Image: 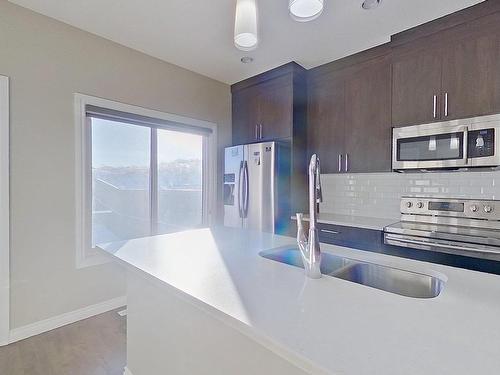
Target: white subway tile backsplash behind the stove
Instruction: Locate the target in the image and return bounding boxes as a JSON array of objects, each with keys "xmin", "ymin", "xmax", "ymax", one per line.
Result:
[{"xmin": 320, "ymin": 171, "xmax": 500, "ymax": 219}]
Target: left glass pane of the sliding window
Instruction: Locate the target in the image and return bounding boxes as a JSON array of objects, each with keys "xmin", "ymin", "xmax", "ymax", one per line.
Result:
[{"xmin": 90, "ymin": 117, "xmax": 152, "ymax": 247}]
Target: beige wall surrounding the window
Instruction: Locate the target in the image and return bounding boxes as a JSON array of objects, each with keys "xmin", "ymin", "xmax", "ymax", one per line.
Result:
[{"xmin": 0, "ymin": 0, "xmax": 231, "ymax": 328}]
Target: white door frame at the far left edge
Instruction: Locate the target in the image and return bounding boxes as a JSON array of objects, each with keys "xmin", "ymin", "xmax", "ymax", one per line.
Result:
[{"xmin": 0, "ymin": 76, "xmax": 10, "ymax": 346}]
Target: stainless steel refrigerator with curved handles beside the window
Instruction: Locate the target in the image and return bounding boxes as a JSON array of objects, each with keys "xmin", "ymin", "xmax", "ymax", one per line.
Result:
[{"xmin": 224, "ymin": 142, "xmax": 291, "ymax": 234}]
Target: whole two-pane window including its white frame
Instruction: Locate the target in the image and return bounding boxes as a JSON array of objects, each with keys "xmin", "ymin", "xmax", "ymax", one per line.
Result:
[{"xmin": 76, "ymin": 94, "xmax": 216, "ymax": 267}]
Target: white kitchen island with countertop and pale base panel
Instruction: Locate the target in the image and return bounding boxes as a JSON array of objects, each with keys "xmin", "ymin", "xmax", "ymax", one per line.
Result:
[{"xmin": 100, "ymin": 227, "xmax": 500, "ymax": 375}]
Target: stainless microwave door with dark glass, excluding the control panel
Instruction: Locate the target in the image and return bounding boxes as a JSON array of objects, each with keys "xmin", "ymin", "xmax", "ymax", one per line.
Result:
[{"xmin": 392, "ymin": 124, "xmax": 468, "ymax": 170}]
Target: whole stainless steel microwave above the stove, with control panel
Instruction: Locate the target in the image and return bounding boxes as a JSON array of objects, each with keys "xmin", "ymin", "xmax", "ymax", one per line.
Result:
[{"xmin": 392, "ymin": 114, "xmax": 500, "ymax": 171}]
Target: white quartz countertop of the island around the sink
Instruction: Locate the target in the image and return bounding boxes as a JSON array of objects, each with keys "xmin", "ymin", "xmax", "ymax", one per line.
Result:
[{"xmin": 100, "ymin": 227, "xmax": 500, "ymax": 375}]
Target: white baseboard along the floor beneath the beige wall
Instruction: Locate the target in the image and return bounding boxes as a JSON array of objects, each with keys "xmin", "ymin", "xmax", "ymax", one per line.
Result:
[{"xmin": 9, "ymin": 296, "xmax": 127, "ymax": 343}]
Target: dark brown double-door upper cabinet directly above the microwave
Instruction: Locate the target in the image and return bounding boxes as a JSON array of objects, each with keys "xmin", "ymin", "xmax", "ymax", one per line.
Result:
[{"xmin": 392, "ymin": 3, "xmax": 500, "ymax": 126}]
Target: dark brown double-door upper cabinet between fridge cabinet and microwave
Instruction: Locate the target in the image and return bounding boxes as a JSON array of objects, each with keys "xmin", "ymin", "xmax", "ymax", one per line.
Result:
[{"xmin": 308, "ymin": 46, "xmax": 391, "ymax": 173}]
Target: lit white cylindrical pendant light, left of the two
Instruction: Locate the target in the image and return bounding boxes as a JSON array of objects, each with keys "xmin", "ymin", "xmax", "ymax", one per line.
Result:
[{"xmin": 234, "ymin": 0, "xmax": 259, "ymax": 51}]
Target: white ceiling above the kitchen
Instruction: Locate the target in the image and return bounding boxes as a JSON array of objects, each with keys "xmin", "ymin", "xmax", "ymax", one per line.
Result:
[{"xmin": 11, "ymin": 0, "xmax": 482, "ymax": 84}]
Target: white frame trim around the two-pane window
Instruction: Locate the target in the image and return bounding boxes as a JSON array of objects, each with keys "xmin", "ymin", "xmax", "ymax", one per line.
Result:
[{"xmin": 74, "ymin": 93, "xmax": 217, "ymax": 268}]
